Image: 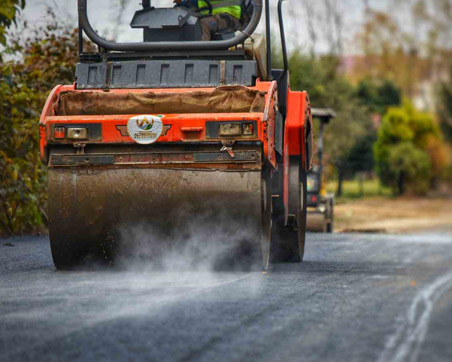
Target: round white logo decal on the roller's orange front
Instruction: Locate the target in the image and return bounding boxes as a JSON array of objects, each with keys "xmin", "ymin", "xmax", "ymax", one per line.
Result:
[{"xmin": 127, "ymin": 115, "xmax": 163, "ymax": 145}]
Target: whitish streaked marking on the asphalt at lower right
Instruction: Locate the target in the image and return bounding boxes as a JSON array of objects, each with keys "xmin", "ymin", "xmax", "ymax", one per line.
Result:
[{"xmin": 378, "ymin": 270, "xmax": 452, "ymax": 362}]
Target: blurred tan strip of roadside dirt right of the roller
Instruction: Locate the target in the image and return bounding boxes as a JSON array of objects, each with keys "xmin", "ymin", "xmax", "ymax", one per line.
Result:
[{"xmin": 335, "ymin": 198, "xmax": 452, "ymax": 233}]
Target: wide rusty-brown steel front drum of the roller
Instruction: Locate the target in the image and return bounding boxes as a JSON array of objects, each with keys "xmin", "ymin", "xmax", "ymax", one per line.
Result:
[{"xmin": 48, "ymin": 168, "xmax": 265, "ymax": 269}]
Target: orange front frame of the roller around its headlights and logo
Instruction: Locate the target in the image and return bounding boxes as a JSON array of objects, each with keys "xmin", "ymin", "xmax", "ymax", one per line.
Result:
[{"xmin": 39, "ymin": 81, "xmax": 277, "ymax": 167}]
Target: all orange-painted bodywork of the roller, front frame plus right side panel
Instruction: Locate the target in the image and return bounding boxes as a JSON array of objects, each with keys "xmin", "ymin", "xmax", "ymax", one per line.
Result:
[{"xmin": 39, "ymin": 80, "xmax": 312, "ymax": 215}]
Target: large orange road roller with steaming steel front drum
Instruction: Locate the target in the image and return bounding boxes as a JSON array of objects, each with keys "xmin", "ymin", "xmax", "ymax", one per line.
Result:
[{"xmin": 40, "ymin": 0, "xmax": 313, "ymax": 269}]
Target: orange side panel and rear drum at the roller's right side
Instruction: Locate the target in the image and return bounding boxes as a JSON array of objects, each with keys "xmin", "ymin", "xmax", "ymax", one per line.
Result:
[{"xmin": 272, "ymin": 90, "xmax": 313, "ymax": 263}]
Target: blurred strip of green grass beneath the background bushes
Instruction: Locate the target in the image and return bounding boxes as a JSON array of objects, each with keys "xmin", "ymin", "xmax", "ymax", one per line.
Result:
[{"xmin": 326, "ymin": 178, "xmax": 392, "ymax": 200}]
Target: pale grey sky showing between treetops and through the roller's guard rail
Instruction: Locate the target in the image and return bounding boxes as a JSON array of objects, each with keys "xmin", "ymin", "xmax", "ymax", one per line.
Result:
[{"xmin": 21, "ymin": 0, "xmax": 391, "ymax": 54}]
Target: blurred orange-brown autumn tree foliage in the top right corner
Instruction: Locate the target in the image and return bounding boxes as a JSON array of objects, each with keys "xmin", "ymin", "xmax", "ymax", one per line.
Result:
[{"xmin": 352, "ymin": 0, "xmax": 452, "ymax": 110}]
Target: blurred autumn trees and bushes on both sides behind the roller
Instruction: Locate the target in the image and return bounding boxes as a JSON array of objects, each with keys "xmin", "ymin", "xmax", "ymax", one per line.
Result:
[{"xmin": 0, "ymin": 0, "xmax": 452, "ymax": 235}]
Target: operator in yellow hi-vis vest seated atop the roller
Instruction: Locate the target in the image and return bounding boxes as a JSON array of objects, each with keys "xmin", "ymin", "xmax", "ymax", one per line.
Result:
[{"xmin": 174, "ymin": 0, "xmax": 243, "ymax": 41}]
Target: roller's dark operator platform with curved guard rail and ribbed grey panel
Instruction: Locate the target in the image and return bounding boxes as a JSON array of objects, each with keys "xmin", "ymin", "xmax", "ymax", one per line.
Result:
[{"xmin": 76, "ymin": 0, "xmax": 272, "ymax": 89}]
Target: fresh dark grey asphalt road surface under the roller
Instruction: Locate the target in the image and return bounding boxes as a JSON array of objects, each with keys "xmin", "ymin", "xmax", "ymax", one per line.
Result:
[{"xmin": 0, "ymin": 233, "xmax": 452, "ymax": 362}]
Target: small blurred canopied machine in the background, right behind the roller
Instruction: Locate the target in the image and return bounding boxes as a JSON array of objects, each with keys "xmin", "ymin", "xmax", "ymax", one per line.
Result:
[{"xmin": 307, "ymin": 108, "xmax": 336, "ymax": 233}]
